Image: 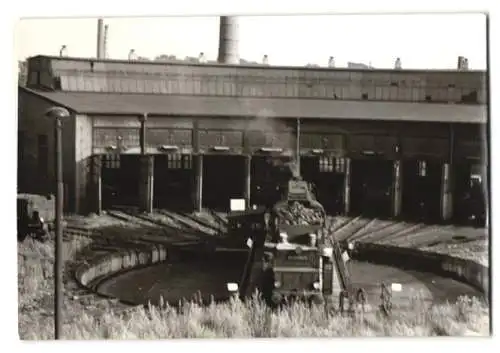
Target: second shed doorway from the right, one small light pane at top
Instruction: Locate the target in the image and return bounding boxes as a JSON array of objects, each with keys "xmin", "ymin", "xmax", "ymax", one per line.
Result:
[{"xmin": 402, "ymin": 159, "xmax": 443, "ymax": 223}]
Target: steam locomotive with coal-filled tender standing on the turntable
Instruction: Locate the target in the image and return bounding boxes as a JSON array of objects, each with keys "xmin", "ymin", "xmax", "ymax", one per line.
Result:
[{"xmin": 228, "ymin": 177, "xmax": 347, "ymax": 303}]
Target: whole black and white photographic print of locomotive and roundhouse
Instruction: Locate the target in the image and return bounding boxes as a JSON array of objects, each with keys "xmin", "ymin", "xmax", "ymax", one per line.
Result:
[{"xmin": 10, "ymin": 1, "xmax": 492, "ymax": 341}]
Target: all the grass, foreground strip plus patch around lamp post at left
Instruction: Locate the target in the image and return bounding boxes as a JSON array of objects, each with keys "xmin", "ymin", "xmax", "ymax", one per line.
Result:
[{"xmin": 18, "ymin": 239, "xmax": 489, "ymax": 340}]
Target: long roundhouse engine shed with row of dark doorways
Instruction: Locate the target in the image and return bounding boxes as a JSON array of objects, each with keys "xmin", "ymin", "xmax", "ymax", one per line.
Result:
[{"xmin": 18, "ymin": 56, "xmax": 488, "ymax": 221}]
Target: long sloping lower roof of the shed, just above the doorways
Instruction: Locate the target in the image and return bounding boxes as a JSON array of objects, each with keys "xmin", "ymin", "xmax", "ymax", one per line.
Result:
[{"xmin": 20, "ymin": 87, "xmax": 487, "ymax": 123}]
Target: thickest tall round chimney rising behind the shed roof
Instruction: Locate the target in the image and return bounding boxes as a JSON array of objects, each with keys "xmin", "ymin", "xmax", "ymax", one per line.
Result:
[{"xmin": 217, "ymin": 16, "xmax": 240, "ymax": 64}]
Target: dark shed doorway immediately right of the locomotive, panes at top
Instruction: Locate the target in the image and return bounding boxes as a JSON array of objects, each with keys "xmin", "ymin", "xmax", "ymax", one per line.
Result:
[{"xmin": 300, "ymin": 157, "xmax": 346, "ymax": 215}]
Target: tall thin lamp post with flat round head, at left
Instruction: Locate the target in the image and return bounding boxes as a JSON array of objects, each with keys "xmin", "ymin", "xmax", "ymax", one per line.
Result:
[{"xmin": 45, "ymin": 107, "xmax": 70, "ymax": 340}]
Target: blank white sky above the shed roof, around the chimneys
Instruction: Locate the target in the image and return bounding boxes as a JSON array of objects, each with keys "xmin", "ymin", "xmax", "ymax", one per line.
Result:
[{"xmin": 15, "ymin": 14, "xmax": 486, "ymax": 70}]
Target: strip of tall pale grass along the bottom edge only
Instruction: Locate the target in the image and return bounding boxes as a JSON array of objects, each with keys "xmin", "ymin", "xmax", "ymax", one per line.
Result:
[{"xmin": 24, "ymin": 292, "xmax": 488, "ymax": 339}]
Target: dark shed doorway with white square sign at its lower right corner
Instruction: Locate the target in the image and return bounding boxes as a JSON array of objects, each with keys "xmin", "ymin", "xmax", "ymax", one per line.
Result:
[{"xmin": 202, "ymin": 155, "xmax": 245, "ymax": 212}]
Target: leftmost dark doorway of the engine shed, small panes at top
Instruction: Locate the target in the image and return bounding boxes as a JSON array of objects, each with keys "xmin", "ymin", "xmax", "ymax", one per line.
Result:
[{"xmin": 101, "ymin": 154, "xmax": 141, "ymax": 209}]
